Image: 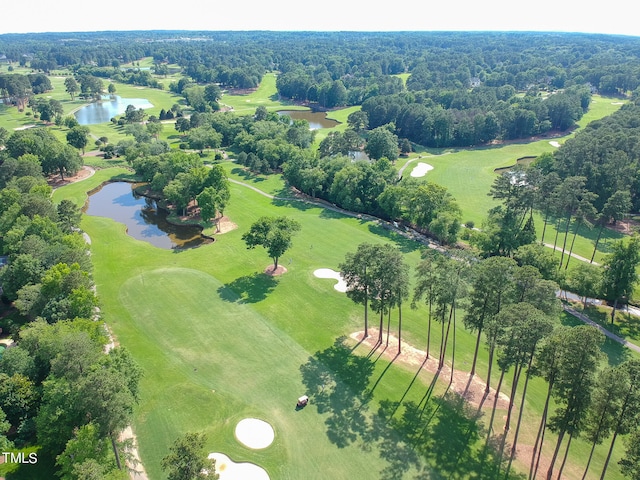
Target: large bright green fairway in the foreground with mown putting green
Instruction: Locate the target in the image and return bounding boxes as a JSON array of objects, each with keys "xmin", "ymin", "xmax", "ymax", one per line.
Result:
[{"xmin": 47, "ymin": 163, "xmax": 629, "ymax": 480}]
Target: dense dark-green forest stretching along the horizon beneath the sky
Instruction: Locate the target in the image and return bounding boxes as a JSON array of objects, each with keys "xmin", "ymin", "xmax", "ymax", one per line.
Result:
[{"xmin": 0, "ymin": 32, "xmax": 640, "ymax": 147}]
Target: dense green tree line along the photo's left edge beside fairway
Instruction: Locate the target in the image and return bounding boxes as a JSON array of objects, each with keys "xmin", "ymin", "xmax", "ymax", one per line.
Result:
[{"xmin": 0, "ymin": 135, "xmax": 141, "ymax": 479}]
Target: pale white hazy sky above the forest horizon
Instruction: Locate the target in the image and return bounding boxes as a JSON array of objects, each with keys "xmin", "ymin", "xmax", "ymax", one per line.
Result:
[{"xmin": 0, "ymin": 0, "xmax": 640, "ymax": 36}]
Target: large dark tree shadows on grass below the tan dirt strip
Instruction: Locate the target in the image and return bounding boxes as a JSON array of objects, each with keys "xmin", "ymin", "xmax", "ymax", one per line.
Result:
[{"xmin": 300, "ymin": 338, "xmax": 524, "ymax": 480}]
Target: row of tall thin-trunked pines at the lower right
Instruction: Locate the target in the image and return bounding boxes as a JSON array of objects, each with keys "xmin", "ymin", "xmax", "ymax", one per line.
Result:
[{"xmin": 339, "ymin": 243, "xmax": 640, "ymax": 478}]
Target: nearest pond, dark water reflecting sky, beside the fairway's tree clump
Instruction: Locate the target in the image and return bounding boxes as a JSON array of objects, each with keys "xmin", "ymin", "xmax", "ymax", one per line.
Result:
[{"xmin": 85, "ymin": 182, "xmax": 212, "ymax": 250}]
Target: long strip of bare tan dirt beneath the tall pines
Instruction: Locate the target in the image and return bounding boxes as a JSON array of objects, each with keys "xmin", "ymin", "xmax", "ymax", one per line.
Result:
[{"xmin": 350, "ymin": 328, "xmax": 510, "ymax": 411}]
